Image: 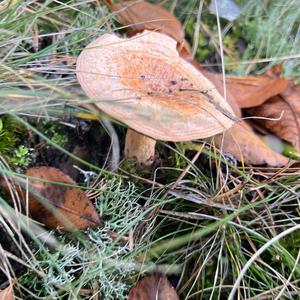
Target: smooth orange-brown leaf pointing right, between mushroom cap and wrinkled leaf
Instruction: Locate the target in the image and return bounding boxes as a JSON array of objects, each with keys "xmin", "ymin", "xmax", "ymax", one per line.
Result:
[{"xmin": 226, "ymin": 73, "xmax": 289, "ymax": 108}]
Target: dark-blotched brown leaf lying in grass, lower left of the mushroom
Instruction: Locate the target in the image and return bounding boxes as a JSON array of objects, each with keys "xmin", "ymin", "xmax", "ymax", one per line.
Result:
[{"xmin": 2, "ymin": 167, "xmax": 100, "ymax": 231}]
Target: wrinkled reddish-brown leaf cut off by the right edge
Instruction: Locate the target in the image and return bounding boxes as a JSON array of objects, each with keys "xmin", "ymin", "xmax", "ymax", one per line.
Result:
[{"xmin": 248, "ymin": 82, "xmax": 300, "ymax": 151}]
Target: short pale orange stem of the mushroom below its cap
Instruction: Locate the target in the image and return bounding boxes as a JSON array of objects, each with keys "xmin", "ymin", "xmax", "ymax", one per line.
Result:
[{"xmin": 124, "ymin": 129, "xmax": 156, "ymax": 166}]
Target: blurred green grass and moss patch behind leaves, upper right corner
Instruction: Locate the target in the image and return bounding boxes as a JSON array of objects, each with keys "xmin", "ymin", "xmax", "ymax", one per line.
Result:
[{"xmin": 177, "ymin": 0, "xmax": 300, "ymax": 81}]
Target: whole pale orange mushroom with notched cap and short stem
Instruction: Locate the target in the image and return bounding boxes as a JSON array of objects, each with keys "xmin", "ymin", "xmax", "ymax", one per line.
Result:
[{"xmin": 76, "ymin": 31, "xmax": 235, "ymax": 165}]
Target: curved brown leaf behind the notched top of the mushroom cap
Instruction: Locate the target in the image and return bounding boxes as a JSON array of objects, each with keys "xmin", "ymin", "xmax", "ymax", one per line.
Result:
[{"xmin": 104, "ymin": 0, "xmax": 193, "ymax": 61}]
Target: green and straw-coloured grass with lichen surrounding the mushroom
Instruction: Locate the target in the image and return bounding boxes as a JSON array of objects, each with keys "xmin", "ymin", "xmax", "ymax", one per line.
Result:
[{"xmin": 0, "ymin": 0, "xmax": 300, "ymax": 299}]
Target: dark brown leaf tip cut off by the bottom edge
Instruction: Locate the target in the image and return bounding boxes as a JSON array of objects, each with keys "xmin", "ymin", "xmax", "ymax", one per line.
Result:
[{"xmin": 127, "ymin": 275, "xmax": 179, "ymax": 300}]
